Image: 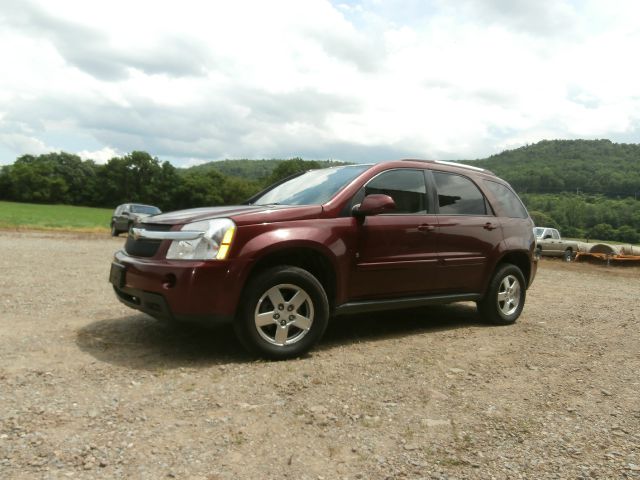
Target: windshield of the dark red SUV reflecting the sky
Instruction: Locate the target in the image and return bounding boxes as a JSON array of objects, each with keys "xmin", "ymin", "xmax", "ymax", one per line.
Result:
[{"xmin": 251, "ymin": 165, "xmax": 371, "ymax": 205}]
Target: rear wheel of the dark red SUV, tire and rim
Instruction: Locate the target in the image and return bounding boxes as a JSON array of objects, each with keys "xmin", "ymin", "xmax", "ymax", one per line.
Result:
[{"xmin": 477, "ymin": 263, "xmax": 527, "ymax": 325}]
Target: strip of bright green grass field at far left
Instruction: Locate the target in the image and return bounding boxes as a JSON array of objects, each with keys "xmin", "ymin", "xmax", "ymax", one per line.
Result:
[{"xmin": 0, "ymin": 202, "xmax": 113, "ymax": 232}]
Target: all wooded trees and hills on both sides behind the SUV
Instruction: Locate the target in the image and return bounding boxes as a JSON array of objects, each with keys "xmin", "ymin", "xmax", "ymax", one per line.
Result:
[{"xmin": 0, "ymin": 140, "xmax": 640, "ymax": 243}]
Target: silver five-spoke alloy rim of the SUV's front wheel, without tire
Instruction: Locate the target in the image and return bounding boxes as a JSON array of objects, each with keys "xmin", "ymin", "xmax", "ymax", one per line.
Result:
[{"xmin": 253, "ymin": 283, "xmax": 314, "ymax": 347}]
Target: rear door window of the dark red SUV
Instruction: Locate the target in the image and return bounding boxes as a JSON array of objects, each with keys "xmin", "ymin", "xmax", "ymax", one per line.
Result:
[{"xmin": 433, "ymin": 172, "xmax": 487, "ymax": 215}]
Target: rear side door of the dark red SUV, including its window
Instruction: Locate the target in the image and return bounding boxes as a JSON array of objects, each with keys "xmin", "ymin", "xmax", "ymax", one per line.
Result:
[{"xmin": 432, "ymin": 171, "xmax": 503, "ymax": 293}]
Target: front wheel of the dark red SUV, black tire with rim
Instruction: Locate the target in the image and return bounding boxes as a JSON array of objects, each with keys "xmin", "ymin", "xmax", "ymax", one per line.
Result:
[{"xmin": 234, "ymin": 265, "xmax": 329, "ymax": 360}]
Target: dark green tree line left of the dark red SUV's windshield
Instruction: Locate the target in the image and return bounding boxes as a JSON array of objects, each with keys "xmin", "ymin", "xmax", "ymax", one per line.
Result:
[{"xmin": 0, "ymin": 151, "xmax": 322, "ymax": 210}]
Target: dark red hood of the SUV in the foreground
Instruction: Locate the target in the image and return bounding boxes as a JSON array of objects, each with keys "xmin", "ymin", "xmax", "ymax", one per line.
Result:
[{"xmin": 143, "ymin": 205, "xmax": 322, "ymax": 225}]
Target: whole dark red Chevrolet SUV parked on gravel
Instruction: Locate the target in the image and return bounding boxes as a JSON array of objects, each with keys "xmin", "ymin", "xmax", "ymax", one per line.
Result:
[{"xmin": 110, "ymin": 160, "xmax": 537, "ymax": 358}]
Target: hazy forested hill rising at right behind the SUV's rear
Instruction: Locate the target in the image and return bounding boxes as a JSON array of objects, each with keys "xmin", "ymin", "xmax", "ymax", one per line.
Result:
[{"xmin": 464, "ymin": 140, "xmax": 640, "ymax": 198}]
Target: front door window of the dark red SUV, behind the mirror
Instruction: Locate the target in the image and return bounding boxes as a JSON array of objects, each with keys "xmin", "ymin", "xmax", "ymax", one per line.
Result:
[{"xmin": 362, "ymin": 168, "xmax": 429, "ymax": 213}]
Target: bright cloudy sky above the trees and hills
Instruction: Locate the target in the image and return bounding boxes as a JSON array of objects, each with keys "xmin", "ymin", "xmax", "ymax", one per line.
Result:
[{"xmin": 0, "ymin": 0, "xmax": 640, "ymax": 167}]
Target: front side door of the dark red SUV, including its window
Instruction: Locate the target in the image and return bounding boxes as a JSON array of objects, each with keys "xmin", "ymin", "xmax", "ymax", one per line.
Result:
[{"xmin": 349, "ymin": 168, "xmax": 438, "ymax": 299}]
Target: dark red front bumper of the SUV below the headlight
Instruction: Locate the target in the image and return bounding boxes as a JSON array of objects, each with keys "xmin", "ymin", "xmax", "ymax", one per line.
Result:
[{"xmin": 109, "ymin": 250, "xmax": 247, "ymax": 323}]
